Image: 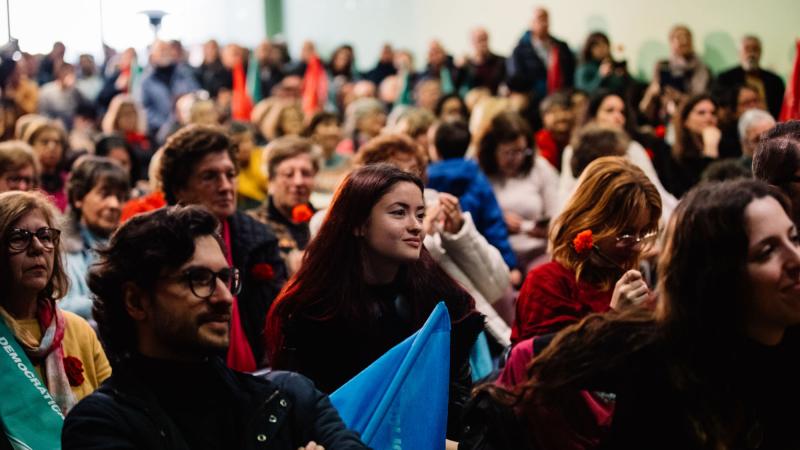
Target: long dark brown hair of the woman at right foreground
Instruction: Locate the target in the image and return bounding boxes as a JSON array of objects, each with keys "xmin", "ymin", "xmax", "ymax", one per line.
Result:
[{"xmin": 481, "ymin": 180, "xmax": 790, "ymax": 448}]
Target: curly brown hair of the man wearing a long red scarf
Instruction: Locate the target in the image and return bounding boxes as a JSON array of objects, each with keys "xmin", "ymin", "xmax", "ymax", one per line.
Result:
[{"xmin": 161, "ymin": 125, "xmax": 236, "ymax": 205}]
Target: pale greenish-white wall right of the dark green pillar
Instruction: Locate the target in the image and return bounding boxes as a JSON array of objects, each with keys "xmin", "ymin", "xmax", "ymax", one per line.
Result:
[{"xmin": 284, "ymin": 0, "xmax": 800, "ymax": 81}]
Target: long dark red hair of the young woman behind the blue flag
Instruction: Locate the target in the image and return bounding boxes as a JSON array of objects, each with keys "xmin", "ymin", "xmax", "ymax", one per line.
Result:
[{"xmin": 265, "ymin": 164, "xmax": 473, "ymax": 367}]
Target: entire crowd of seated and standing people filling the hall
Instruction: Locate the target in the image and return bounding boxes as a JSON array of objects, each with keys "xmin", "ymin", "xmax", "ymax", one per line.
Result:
[{"xmin": 0, "ymin": 7, "xmax": 800, "ymax": 450}]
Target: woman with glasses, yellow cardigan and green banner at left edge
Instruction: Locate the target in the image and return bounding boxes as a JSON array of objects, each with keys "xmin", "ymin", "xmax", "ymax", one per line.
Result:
[{"xmin": 0, "ymin": 191, "xmax": 111, "ymax": 448}]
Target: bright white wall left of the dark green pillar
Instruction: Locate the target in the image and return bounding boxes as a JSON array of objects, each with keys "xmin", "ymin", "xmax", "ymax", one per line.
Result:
[{"xmin": 5, "ymin": 0, "xmax": 266, "ymax": 60}]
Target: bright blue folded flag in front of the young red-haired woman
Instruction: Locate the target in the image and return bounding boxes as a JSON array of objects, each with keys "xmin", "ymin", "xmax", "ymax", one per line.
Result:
[{"xmin": 330, "ymin": 302, "xmax": 450, "ymax": 450}]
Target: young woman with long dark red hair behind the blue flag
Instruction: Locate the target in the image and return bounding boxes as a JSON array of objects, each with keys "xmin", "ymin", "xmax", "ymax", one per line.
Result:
[{"xmin": 265, "ymin": 164, "xmax": 483, "ymax": 440}]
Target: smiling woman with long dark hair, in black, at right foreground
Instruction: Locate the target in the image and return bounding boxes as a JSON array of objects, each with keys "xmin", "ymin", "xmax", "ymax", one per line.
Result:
[{"xmin": 459, "ymin": 180, "xmax": 800, "ymax": 450}]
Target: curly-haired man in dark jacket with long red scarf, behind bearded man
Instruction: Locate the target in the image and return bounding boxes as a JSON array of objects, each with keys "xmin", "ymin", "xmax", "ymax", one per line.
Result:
[{"xmin": 161, "ymin": 125, "xmax": 286, "ymax": 372}]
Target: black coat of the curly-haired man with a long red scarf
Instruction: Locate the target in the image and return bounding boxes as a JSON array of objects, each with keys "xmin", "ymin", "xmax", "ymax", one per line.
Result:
[{"xmin": 228, "ymin": 211, "xmax": 286, "ymax": 367}]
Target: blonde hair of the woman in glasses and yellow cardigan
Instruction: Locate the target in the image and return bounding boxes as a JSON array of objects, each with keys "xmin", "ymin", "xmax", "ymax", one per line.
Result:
[{"xmin": 0, "ymin": 191, "xmax": 69, "ymax": 300}]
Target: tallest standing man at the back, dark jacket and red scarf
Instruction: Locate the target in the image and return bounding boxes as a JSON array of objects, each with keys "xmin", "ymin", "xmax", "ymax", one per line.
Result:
[{"xmin": 506, "ymin": 7, "xmax": 575, "ymax": 98}]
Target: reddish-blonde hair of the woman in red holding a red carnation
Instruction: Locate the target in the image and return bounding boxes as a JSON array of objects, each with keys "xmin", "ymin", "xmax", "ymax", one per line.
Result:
[{"xmin": 550, "ymin": 156, "xmax": 661, "ymax": 289}]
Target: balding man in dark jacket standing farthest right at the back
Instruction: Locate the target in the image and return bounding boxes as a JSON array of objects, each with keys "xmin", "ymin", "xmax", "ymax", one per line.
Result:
[{"xmin": 717, "ymin": 36, "xmax": 785, "ymax": 118}]
